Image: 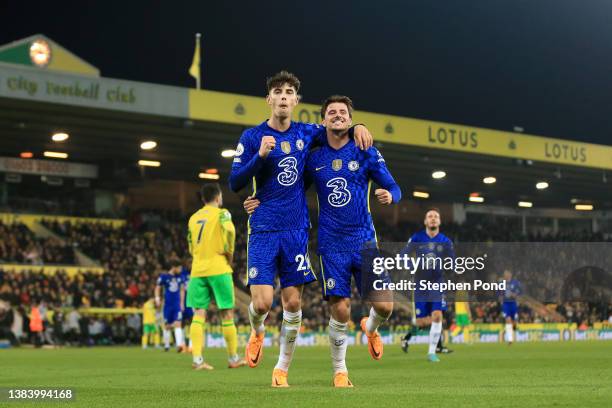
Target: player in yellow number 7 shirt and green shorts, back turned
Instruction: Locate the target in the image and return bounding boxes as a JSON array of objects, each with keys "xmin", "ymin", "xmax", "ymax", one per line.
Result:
[{"xmin": 187, "ymin": 183, "xmax": 246, "ymax": 370}]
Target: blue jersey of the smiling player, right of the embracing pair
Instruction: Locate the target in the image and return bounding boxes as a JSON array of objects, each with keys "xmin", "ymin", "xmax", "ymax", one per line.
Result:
[{"xmin": 306, "ymin": 139, "xmax": 401, "ymax": 254}]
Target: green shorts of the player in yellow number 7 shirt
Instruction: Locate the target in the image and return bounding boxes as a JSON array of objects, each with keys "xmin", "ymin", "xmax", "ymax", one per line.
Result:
[{"xmin": 187, "ymin": 273, "xmax": 235, "ymax": 310}]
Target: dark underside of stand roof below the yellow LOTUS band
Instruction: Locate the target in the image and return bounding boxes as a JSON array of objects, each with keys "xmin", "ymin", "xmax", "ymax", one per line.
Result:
[{"xmin": 0, "ymin": 98, "xmax": 612, "ymax": 209}]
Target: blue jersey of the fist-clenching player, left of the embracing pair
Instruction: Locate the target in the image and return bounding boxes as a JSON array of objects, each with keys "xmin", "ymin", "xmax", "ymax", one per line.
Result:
[{"xmin": 230, "ymin": 121, "xmax": 325, "ymax": 232}]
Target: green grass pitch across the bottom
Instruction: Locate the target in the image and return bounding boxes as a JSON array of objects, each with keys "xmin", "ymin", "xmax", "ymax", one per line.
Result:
[{"xmin": 0, "ymin": 341, "xmax": 612, "ymax": 408}]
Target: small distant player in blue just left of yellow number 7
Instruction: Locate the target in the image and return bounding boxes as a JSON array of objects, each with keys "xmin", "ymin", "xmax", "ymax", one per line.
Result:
[{"xmin": 155, "ymin": 259, "xmax": 185, "ymax": 353}]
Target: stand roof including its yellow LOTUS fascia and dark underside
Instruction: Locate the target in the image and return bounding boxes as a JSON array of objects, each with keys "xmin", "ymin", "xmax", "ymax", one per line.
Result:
[{"xmin": 0, "ymin": 35, "xmax": 612, "ymax": 209}]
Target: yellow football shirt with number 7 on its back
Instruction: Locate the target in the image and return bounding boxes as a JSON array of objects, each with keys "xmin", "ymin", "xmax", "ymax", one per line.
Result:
[{"xmin": 187, "ymin": 205, "xmax": 236, "ymax": 278}]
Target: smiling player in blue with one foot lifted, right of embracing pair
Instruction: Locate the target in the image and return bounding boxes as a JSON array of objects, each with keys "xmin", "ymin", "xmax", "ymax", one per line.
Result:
[{"xmin": 245, "ymin": 95, "xmax": 401, "ymax": 387}]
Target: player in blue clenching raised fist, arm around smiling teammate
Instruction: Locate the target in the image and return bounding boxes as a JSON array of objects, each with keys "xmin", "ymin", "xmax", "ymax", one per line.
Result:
[{"xmin": 230, "ymin": 71, "xmax": 372, "ymax": 387}]
